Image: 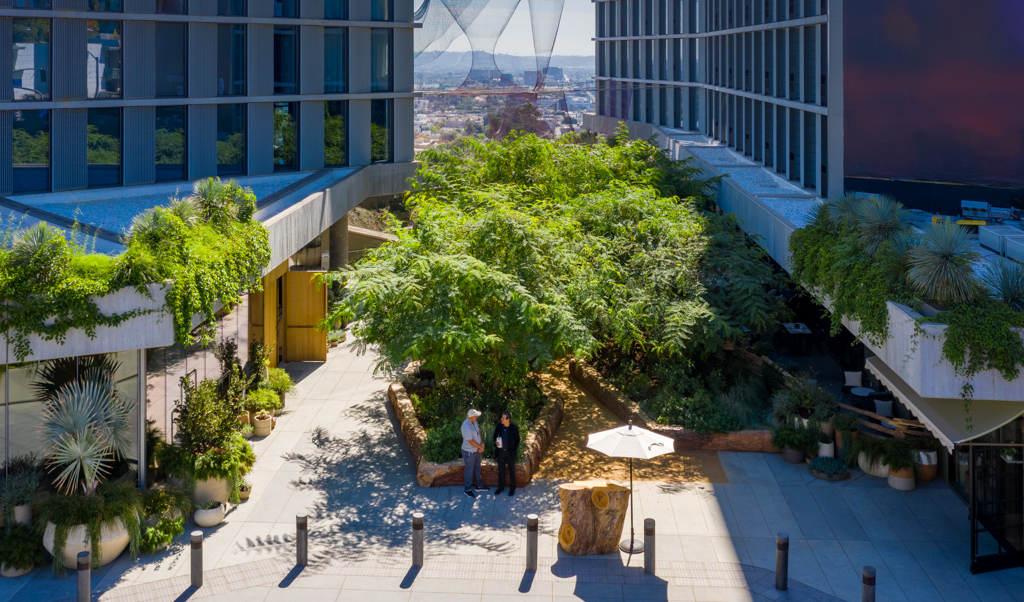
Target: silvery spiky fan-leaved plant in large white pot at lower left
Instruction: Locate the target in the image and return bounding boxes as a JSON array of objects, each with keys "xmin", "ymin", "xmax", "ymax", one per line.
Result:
[{"xmin": 42, "ymin": 371, "xmax": 131, "ymax": 495}]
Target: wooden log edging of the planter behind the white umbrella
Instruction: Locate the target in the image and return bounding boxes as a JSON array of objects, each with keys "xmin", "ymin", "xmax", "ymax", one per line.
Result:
[{"xmin": 569, "ymin": 359, "xmax": 778, "ymax": 453}]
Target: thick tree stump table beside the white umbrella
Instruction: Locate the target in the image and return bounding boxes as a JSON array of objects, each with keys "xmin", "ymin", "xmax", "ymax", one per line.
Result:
[{"xmin": 558, "ymin": 481, "xmax": 630, "ymax": 556}]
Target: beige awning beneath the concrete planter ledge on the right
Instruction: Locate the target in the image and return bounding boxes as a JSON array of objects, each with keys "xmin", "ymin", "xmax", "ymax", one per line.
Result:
[{"xmin": 867, "ymin": 357, "xmax": 1024, "ymax": 453}]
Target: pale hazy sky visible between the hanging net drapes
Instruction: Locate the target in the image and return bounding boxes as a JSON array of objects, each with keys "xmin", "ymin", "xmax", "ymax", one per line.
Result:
[{"xmin": 449, "ymin": 0, "xmax": 594, "ymax": 56}]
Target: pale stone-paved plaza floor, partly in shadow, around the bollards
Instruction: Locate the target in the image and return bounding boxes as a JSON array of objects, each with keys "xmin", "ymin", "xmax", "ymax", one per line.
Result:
[{"xmin": 0, "ymin": 345, "xmax": 1024, "ymax": 602}]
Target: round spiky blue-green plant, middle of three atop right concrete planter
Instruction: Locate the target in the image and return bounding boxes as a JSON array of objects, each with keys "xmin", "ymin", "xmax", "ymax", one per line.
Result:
[{"xmin": 907, "ymin": 219, "xmax": 978, "ymax": 304}]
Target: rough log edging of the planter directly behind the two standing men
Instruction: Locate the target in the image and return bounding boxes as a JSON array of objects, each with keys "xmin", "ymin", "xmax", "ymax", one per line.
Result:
[{"xmin": 387, "ymin": 366, "xmax": 565, "ymax": 487}]
